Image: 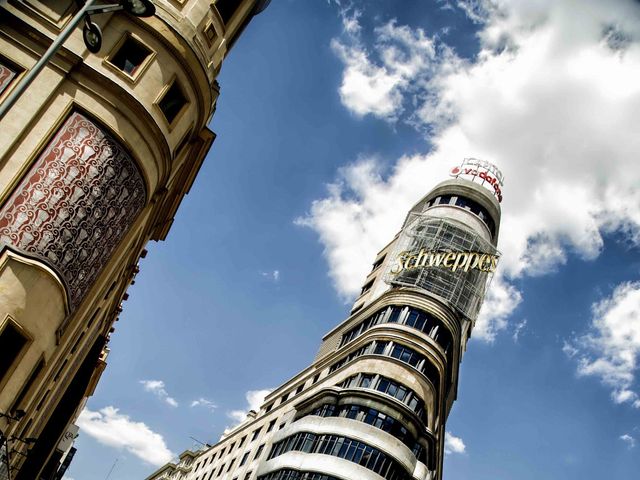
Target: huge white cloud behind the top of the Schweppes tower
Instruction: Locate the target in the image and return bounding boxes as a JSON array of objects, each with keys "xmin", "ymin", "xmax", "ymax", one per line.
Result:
[{"xmin": 296, "ymin": 0, "xmax": 640, "ymax": 340}]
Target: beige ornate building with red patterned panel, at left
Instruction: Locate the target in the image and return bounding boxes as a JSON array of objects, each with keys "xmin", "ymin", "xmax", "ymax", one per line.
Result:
[{"xmin": 0, "ymin": 0, "xmax": 269, "ymax": 480}]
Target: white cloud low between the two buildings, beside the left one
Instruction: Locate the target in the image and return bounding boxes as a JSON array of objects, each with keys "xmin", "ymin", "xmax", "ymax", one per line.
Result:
[{"xmin": 78, "ymin": 406, "xmax": 174, "ymax": 466}]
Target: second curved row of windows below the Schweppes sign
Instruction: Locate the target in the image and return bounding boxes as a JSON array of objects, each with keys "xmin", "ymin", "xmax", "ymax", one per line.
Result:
[{"xmin": 329, "ymin": 340, "xmax": 440, "ymax": 394}]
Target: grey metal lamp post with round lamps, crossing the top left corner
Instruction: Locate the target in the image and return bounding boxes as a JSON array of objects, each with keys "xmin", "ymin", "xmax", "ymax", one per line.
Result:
[{"xmin": 0, "ymin": 0, "xmax": 156, "ymax": 120}]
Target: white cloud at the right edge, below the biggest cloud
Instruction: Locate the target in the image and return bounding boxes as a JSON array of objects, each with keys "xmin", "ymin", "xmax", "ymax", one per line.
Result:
[{"xmin": 563, "ymin": 282, "xmax": 640, "ymax": 408}]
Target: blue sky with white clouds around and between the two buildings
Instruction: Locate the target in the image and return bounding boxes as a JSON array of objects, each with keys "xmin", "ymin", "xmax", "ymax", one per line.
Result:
[{"xmin": 67, "ymin": 0, "xmax": 640, "ymax": 480}]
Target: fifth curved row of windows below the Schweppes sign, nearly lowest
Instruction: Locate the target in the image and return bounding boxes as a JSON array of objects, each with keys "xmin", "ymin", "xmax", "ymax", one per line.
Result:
[{"xmin": 269, "ymin": 432, "xmax": 411, "ymax": 480}]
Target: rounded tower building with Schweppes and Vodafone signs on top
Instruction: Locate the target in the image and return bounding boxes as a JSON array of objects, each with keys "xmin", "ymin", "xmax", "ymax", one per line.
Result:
[{"xmin": 147, "ymin": 163, "xmax": 502, "ymax": 480}]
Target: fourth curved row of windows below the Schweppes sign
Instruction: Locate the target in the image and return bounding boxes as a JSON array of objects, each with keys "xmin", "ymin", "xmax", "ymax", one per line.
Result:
[{"xmin": 310, "ymin": 403, "xmax": 427, "ymax": 463}]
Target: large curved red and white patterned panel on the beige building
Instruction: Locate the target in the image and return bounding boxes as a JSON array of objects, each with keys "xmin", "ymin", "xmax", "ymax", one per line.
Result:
[{"xmin": 0, "ymin": 112, "xmax": 146, "ymax": 310}]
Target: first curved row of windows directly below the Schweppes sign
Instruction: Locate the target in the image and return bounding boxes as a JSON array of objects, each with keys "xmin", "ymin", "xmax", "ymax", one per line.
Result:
[{"xmin": 340, "ymin": 305, "xmax": 453, "ymax": 354}]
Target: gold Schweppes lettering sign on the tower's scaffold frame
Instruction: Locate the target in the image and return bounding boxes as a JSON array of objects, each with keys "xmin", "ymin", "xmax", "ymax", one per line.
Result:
[{"xmin": 390, "ymin": 248, "xmax": 499, "ymax": 275}]
